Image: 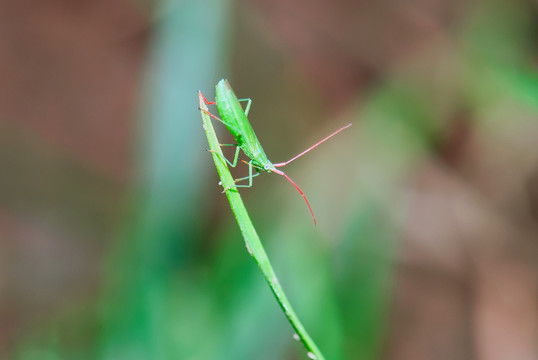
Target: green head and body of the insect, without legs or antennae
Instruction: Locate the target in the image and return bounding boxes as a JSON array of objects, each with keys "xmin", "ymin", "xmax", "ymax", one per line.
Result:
[{"xmin": 215, "ymin": 79, "xmax": 274, "ymax": 172}]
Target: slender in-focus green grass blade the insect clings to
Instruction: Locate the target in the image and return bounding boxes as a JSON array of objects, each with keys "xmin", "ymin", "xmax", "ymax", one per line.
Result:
[{"xmin": 200, "ymin": 93, "xmax": 325, "ymax": 360}]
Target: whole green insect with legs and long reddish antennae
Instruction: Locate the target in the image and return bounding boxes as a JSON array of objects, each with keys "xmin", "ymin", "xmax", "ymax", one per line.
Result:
[{"xmin": 199, "ymin": 79, "xmax": 351, "ymax": 225}]
